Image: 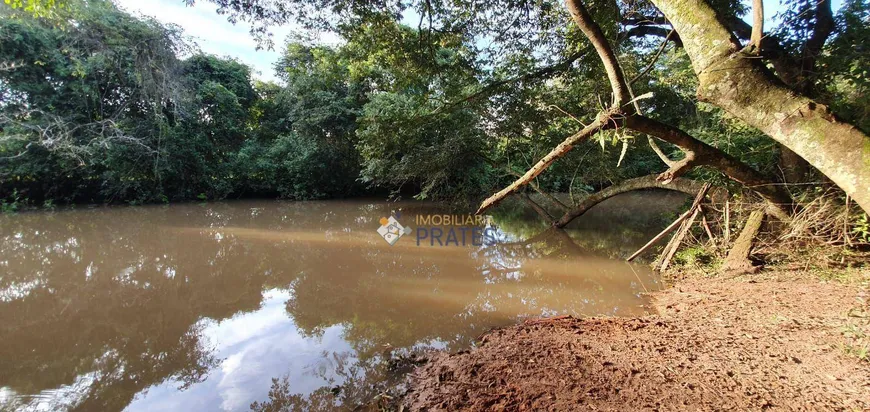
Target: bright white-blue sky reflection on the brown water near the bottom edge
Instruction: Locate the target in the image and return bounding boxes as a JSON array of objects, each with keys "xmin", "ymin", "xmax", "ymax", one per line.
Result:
[{"xmin": 128, "ymin": 290, "xmax": 352, "ymax": 411}]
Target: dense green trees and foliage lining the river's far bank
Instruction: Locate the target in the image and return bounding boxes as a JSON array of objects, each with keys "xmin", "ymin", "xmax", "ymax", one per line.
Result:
[{"xmin": 0, "ymin": 0, "xmax": 870, "ymax": 205}]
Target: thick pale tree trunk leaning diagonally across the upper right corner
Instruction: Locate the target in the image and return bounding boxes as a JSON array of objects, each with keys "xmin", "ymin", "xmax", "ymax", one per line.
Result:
[{"xmin": 652, "ymin": 0, "xmax": 870, "ymax": 211}]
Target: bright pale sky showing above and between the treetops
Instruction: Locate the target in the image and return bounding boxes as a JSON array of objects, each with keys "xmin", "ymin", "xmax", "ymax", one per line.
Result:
[{"xmin": 115, "ymin": 0, "xmax": 843, "ymax": 81}]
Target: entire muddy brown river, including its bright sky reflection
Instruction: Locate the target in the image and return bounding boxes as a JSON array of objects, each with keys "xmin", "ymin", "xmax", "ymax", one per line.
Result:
[{"xmin": 0, "ymin": 193, "xmax": 684, "ymax": 411}]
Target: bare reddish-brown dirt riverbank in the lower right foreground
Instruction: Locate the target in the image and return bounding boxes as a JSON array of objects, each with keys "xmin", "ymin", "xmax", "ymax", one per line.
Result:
[{"xmin": 404, "ymin": 270, "xmax": 870, "ymax": 410}]
